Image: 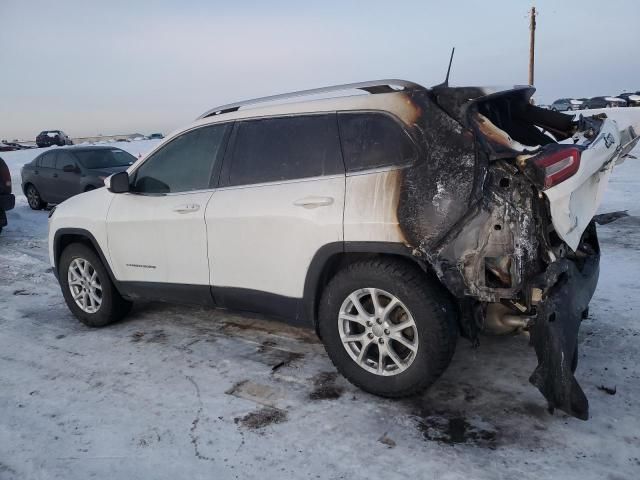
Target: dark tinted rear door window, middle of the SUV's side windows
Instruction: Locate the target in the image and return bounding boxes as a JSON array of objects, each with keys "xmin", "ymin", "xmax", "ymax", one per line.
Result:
[{"xmin": 229, "ymin": 114, "xmax": 344, "ymax": 185}]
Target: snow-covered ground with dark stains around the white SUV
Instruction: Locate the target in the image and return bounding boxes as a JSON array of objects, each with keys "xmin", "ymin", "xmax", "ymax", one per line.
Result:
[{"xmin": 0, "ymin": 127, "xmax": 640, "ymax": 480}]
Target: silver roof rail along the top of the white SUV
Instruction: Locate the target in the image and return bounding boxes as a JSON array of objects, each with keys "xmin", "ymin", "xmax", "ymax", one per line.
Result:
[{"xmin": 197, "ymin": 79, "xmax": 424, "ymax": 120}]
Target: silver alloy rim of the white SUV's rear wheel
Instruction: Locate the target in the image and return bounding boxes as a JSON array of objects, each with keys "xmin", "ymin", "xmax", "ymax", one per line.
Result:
[{"xmin": 338, "ymin": 288, "xmax": 419, "ymax": 376}]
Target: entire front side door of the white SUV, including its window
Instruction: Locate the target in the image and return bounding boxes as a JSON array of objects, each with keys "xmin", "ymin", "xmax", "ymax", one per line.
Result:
[{"xmin": 107, "ymin": 125, "xmax": 231, "ymax": 288}]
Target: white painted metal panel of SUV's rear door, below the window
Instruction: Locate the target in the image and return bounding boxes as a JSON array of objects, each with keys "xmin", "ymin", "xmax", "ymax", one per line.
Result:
[{"xmin": 208, "ymin": 175, "xmax": 345, "ymax": 298}]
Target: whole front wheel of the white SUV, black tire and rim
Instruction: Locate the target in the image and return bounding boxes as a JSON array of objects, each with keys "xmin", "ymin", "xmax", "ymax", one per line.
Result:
[{"xmin": 58, "ymin": 243, "xmax": 132, "ymax": 327}]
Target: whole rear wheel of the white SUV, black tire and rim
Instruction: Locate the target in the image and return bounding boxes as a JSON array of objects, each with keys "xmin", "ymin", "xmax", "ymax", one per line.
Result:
[{"xmin": 319, "ymin": 259, "xmax": 458, "ymax": 398}]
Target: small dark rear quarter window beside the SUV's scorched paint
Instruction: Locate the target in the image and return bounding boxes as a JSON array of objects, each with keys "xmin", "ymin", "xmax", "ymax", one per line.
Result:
[{"xmin": 338, "ymin": 113, "xmax": 416, "ymax": 172}]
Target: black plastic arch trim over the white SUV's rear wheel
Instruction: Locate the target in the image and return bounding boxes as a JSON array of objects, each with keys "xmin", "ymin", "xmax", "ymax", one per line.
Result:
[{"xmin": 298, "ymin": 242, "xmax": 441, "ymax": 335}]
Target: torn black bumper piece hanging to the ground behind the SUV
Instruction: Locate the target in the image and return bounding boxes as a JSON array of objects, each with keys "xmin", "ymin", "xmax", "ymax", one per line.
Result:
[{"xmin": 529, "ymin": 253, "xmax": 600, "ymax": 420}]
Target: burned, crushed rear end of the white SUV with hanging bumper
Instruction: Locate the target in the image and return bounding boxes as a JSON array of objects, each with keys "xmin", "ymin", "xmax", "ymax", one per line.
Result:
[{"xmin": 407, "ymin": 87, "xmax": 632, "ymax": 419}]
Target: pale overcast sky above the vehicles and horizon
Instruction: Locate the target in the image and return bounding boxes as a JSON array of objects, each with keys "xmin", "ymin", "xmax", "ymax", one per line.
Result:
[{"xmin": 0, "ymin": 0, "xmax": 640, "ymax": 139}]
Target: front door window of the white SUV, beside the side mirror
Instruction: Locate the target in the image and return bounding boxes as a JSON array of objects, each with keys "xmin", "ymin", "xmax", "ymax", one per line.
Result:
[{"xmin": 133, "ymin": 125, "xmax": 230, "ymax": 193}]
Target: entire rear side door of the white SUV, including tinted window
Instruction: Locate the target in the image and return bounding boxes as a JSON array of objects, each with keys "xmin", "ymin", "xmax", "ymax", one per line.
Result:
[{"xmin": 206, "ymin": 113, "xmax": 345, "ymax": 306}]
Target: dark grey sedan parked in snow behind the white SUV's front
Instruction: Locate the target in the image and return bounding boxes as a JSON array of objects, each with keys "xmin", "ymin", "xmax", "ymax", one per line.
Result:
[{"xmin": 21, "ymin": 146, "xmax": 136, "ymax": 210}]
